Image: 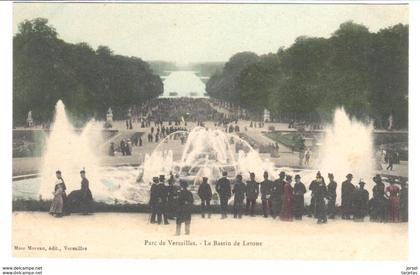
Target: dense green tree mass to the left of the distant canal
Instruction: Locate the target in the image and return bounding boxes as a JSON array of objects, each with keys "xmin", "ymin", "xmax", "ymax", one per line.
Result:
[{"xmin": 13, "ymin": 18, "xmax": 163, "ymax": 125}]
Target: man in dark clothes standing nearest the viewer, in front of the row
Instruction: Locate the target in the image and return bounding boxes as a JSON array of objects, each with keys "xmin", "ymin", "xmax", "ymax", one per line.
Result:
[{"xmin": 176, "ymin": 181, "xmax": 194, "ymax": 235}]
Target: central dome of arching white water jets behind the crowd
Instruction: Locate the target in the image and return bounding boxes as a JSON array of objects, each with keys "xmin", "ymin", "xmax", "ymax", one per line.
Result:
[{"xmin": 140, "ymin": 127, "xmax": 275, "ymax": 187}]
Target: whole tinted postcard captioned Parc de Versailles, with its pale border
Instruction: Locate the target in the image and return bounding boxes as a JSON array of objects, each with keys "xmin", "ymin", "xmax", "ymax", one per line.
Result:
[{"xmin": 4, "ymin": 2, "xmax": 412, "ymax": 271}]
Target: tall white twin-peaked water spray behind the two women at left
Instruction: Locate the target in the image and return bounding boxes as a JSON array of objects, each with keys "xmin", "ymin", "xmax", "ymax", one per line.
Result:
[{"xmin": 39, "ymin": 100, "xmax": 103, "ymax": 199}]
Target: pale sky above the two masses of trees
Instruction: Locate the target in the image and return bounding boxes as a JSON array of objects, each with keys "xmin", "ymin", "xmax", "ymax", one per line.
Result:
[{"xmin": 13, "ymin": 3, "xmax": 409, "ymax": 64}]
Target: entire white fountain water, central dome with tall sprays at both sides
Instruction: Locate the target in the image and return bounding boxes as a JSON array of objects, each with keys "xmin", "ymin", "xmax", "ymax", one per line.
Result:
[{"xmin": 13, "ymin": 101, "xmax": 374, "ymax": 207}]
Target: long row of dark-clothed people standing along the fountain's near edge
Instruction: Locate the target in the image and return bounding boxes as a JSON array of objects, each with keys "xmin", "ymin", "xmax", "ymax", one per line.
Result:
[{"xmin": 149, "ymin": 171, "xmax": 408, "ymax": 235}]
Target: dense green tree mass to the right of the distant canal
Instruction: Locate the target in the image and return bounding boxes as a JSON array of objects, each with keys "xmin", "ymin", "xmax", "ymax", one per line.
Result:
[{"xmin": 206, "ymin": 22, "xmax": 408, "ymax": 128}]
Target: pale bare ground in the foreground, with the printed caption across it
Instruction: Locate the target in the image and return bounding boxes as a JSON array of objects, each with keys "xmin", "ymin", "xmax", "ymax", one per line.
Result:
[{"xmin": 12, "ymin": 212, "xmax": 408, "ymax": 261}]
